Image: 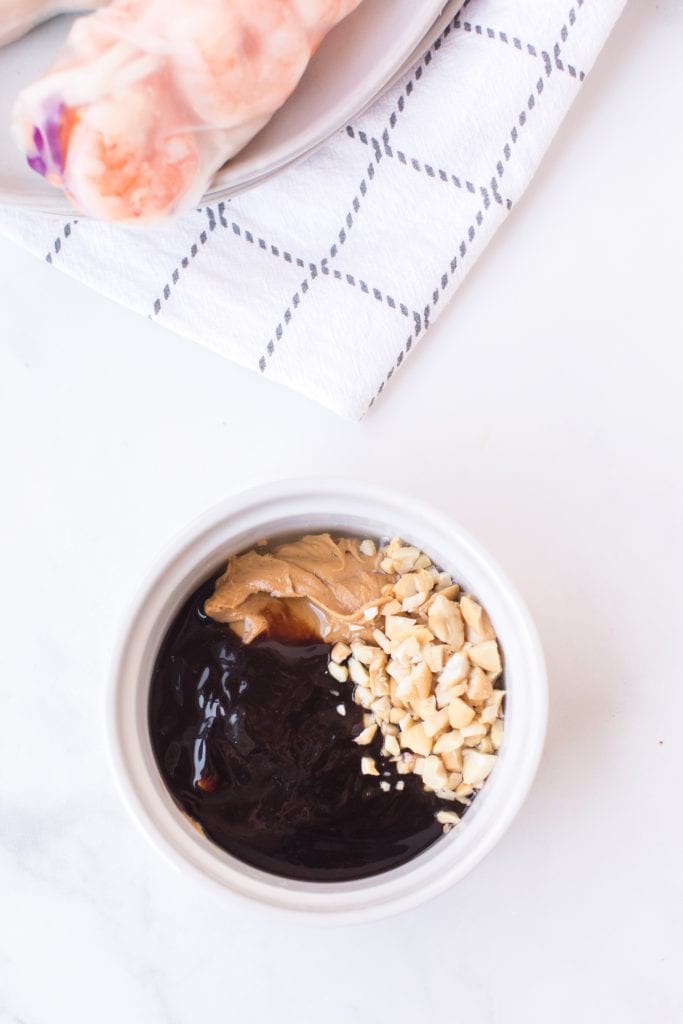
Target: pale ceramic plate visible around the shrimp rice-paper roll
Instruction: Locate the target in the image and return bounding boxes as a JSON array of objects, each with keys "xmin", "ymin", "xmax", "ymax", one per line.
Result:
[{"xmin": 0, "ymin": 0, "xmax": 462, "ymax": 213}]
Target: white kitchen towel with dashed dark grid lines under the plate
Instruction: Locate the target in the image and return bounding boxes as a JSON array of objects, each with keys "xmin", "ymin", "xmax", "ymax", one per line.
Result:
[{"xmin": 0, "ymin": 0, "xmax": 625, "ymax": 419}]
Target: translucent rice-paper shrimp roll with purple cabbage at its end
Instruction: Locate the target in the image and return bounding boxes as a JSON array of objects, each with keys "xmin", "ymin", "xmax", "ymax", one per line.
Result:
[{"xmin": 13, "ymin": 0, "xmax": 360, "ymax": 223}]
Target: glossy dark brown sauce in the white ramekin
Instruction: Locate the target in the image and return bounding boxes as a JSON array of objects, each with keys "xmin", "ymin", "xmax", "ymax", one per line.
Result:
[{"xmin": 148, "ymin": 580, "xmax": 463, "ymax": 882}]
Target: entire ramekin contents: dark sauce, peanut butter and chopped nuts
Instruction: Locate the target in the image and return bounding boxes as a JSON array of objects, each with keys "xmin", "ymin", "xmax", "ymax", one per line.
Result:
[{"xmin": 148, "ymin": 534, "xmax": 505, "ymax": 882}]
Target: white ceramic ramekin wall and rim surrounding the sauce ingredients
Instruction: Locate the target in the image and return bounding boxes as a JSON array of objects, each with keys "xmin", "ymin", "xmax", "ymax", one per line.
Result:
[{"xmin": 108, "ymin": 479, "xmax": 547, "ymax": 923}]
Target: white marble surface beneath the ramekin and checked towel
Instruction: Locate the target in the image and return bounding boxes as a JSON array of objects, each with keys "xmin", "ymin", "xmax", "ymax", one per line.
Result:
[{"xmin": 0, "ymin": 0, "xmax": 683, "ymax": 1024}]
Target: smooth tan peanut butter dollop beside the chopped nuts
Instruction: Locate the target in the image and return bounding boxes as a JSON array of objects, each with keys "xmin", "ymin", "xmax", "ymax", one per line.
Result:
[{"xmin": 204, "ymin": 534, "xmax": 394, "ymax": 643}]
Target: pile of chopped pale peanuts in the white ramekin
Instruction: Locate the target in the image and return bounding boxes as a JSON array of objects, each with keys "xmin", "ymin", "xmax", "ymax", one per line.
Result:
[{"xmin": 329, "ymin": 538, "xmax": 505, "ymax": 831}]
